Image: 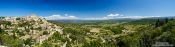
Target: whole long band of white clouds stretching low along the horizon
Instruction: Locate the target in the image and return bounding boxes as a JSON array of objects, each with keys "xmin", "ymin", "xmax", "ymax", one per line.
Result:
[{"xmin": 43, "ymin": 14, "xmax": 163, "ymax": 20}]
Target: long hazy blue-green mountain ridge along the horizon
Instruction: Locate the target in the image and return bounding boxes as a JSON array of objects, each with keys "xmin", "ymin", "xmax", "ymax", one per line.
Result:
[{"xmin": 48, "ymin": 16, "xmax": 175, "ymax": 23}]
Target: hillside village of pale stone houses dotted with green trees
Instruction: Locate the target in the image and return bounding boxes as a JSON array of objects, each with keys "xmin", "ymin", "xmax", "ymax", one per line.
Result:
[{"xmin": 0, "ymin": 15, "xmax": 63, "ymax": 46}]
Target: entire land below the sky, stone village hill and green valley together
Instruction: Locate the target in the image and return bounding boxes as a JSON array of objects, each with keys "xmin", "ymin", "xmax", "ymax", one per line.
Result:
[{"xmin": 0, "ymin": 15, "xmax": 175, "ymax": 47}]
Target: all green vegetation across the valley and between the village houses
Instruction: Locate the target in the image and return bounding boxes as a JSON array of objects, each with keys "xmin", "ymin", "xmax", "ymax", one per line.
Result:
[{"xmin": 0, "ymin": 18, "xmax": 175, "ymax": 47}]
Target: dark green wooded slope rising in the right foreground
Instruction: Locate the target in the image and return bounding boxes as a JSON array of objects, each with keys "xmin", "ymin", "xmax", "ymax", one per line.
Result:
[{"xmin": 116, "ymin": 18, "xmax": 175, "ymax": 47}]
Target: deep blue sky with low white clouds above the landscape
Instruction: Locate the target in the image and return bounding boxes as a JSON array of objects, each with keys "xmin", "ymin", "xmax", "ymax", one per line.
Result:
[{"xmin": 0, "ymin": 0, "xmax": 175, "ymax": 19}]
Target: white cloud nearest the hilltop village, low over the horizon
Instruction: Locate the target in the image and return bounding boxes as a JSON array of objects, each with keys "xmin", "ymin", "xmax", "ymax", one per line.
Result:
[{"xmin": 43, "ymin": 14, "xmax": 78, "ymax": 20}]
